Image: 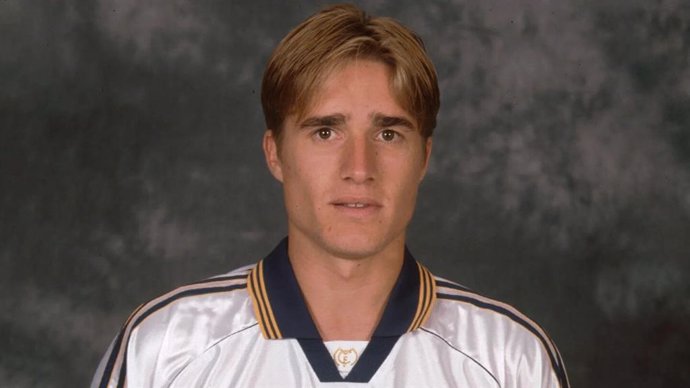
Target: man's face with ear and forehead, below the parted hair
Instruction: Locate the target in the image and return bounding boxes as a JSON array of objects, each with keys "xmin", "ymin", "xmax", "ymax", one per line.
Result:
[{"xmin": 264, "ymin": 60, "xmax": 431, "ymax": 259}]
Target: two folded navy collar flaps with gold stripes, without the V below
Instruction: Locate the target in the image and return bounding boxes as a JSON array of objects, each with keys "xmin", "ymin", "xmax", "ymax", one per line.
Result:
[{"xmin": 247, "ymin": 238, "xmax": 436, "ymax": 340}]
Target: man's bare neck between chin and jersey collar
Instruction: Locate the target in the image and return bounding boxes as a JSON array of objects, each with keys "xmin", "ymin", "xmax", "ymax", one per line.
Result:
[{"xmin": 288, "ymin": 236, "xmax": 405, "ymax": 341}]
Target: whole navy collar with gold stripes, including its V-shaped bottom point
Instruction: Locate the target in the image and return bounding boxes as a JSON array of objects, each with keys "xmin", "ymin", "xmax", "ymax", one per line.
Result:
[{"xmin": 247, "ymin": 238, "xmax": 436, "ymax": 382}]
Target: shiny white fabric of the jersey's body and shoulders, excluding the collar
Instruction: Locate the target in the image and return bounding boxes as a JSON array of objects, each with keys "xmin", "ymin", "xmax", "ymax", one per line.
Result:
[{"xmin": 91, "ymin": 268, "xmax": 567, "ymax": 388}]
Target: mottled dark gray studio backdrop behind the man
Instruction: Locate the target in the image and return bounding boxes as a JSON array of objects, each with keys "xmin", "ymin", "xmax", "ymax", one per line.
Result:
[{"xmin": 0, "ymin": 0, "xmax": 690, "ymax": 387}]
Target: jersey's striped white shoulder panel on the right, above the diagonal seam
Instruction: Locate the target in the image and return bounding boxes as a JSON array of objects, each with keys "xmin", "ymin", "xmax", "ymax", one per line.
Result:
[{"xmin": 422, "ymin": 277, "xmax": 569, "ymax": 388}]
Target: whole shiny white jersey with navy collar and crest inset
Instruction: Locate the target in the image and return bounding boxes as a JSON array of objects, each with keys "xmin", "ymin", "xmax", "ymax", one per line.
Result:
[{"xmin": 91, "ymin": 240, "xmax": 569, "ymax": 388}]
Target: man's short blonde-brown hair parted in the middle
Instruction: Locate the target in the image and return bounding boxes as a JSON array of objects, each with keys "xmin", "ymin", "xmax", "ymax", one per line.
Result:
[{"xmin": 261, "ymin": 5, "xmax": 440, "ymax": 139}]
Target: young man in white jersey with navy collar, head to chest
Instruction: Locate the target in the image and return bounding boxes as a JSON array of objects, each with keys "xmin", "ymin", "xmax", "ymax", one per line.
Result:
[{"xmin": 92, "ymin": 6, "xmax": 568, "ymax": 388}]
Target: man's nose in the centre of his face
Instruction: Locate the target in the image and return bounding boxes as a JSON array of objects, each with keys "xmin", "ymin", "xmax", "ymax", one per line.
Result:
[{"xmin": 341, "ymin": 135, "xmax": 377, "ymax": 183}]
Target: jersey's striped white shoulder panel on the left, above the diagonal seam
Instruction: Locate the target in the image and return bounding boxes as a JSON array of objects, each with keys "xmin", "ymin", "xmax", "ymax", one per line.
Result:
[{"xmin": 92, "ymin": 265, "xmax": 257, "ymax": 387}]
